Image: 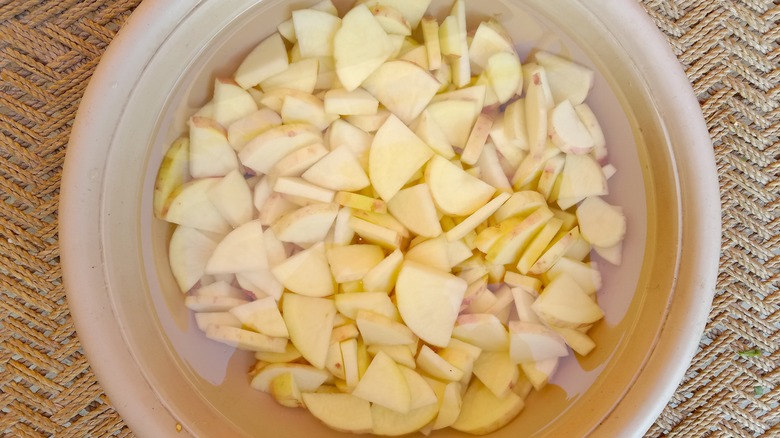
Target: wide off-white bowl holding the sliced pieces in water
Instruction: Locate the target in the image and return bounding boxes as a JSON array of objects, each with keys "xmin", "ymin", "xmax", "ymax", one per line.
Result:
[{"xmin": 60, "ymin": 0, "xmax": 720, "ymax": 437}]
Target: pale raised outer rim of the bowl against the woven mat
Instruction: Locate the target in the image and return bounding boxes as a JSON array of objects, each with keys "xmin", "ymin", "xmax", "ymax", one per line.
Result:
[{"xmin": 59, "ymin": 0, "xmax": 721, "ymax": 436}]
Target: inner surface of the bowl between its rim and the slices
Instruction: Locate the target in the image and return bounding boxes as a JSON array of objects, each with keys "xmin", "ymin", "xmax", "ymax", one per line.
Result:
[{"xmin": 105, "ymin": 0, "xmax": 677, "ymax": 436}]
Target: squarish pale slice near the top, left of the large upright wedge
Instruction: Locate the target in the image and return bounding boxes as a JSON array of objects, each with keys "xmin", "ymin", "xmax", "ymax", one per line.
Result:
[{"xmin": 292, "ymin": 9, "xmax": 341, "ymax": 58}]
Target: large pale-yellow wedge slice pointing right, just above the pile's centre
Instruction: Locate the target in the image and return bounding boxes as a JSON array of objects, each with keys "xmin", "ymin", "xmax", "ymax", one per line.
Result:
[{"xmin": 368, "ymin": 115, "xmax": 436, "ymax": 201}]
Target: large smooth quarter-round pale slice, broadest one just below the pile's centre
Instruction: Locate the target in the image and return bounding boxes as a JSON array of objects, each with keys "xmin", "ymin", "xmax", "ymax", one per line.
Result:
[{"xmin": 395, "ymin": 261, "xmax": 468, "ymax": 347}]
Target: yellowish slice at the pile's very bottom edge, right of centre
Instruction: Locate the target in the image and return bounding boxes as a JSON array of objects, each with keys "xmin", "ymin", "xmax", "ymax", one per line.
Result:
[{"xmin": 452, "ymin": 379, "xmax": 524, "ymax": 435}]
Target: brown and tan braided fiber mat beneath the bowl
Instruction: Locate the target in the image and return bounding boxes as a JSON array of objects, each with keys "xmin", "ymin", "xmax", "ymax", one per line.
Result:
[{"xmin": 0, "ymin": 0, "xmax": 780, "ymax": 437}]
